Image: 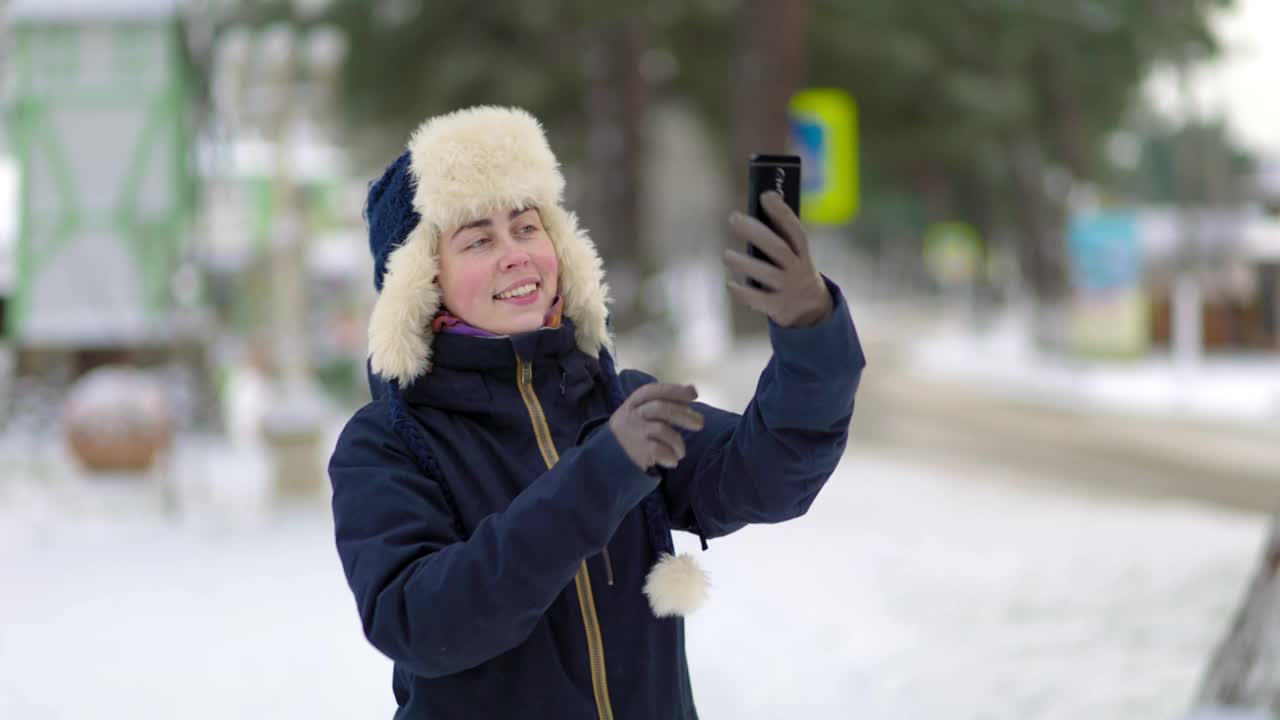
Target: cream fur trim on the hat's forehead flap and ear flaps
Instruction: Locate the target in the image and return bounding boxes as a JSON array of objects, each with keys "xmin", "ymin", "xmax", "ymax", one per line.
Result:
[{"xmin": 369, "ymin": 106, "xmax": 613, "ymax": 387}]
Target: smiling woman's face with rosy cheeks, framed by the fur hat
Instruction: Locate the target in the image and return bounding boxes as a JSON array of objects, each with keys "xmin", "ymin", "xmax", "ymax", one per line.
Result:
[{"xmin": 436, "ymin": 208, "xmax": 559, "ymax": 334}]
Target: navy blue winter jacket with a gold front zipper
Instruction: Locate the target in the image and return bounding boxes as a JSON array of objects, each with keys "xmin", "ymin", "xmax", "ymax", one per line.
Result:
[{"xmin": 329, "ymin": 275, "xmax": 864, "ymax": 720}]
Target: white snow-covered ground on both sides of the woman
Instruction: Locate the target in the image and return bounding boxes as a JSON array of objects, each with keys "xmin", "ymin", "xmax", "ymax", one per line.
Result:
[{"xmin": 0, "ymin": 422, "xmax": 1263, "ymax": 720}]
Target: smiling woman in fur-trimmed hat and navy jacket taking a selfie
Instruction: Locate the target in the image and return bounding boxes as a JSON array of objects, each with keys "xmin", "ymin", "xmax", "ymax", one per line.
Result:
[{"xmin": 329, "ymin": 108, "xmax": 864, "ymax": 720}]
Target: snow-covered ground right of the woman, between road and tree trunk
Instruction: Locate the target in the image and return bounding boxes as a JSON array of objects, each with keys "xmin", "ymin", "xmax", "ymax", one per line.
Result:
[{"xmin": 690, "ymin": 448, "xmax": 1262, "ymax": 720}]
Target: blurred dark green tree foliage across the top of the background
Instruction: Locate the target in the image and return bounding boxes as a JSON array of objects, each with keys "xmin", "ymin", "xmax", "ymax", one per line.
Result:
[{"xmin": 215, "ymin": 0, "xmax": 1233, "ymax": 331}]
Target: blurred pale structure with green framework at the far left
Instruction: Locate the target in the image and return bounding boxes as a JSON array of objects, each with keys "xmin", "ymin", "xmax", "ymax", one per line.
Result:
[{"xmin": 8, "ymin": 0, "xmax": 193, "ymax": 348}]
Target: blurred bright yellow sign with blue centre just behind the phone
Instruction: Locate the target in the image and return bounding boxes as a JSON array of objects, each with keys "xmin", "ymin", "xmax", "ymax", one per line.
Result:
[{"xmin": 790, "ymin": 88, "xmax": 858, "ymax": 225}]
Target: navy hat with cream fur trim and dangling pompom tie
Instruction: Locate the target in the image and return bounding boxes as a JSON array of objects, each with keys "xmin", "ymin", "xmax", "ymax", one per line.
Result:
[{"xmin": 365, "ymin": 106, "xmax": 707, "ymax": 616}]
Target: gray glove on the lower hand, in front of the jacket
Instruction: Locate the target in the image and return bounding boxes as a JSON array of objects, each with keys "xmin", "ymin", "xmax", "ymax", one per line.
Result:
[{"xmin": 609, "ymin": 383, "xmax": 704, "ymax": 473}]
